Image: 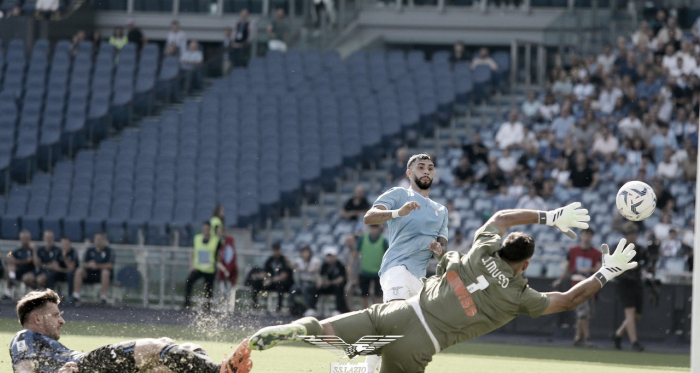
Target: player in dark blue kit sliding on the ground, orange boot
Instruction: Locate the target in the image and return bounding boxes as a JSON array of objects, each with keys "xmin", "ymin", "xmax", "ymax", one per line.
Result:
[{"xmin": 10, "ymin": 289, "xmax": 253, "ymax": 373}]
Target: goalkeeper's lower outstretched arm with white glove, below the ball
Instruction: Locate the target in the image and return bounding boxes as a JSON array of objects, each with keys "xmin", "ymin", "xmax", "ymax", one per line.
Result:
[{"xmin": 542, "ymin": 238, "xmax": 637, "ymax": 315}]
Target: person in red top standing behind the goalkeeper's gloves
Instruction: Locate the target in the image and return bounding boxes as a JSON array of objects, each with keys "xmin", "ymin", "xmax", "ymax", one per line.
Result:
[{"xmin": 552, "ymin": 228, "xmax": 603, "ymax": 347}]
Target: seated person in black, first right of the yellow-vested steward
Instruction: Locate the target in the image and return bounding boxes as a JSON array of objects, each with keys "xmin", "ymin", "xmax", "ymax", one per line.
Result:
[{"xmin": 249, "ymin": 242, "xmax": 292, "ymax": 312}]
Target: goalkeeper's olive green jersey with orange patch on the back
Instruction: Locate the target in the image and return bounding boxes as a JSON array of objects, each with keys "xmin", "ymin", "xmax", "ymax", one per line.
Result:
[{"xmin": 420, "ymin": 225, "xmax": 549, "ymax": 349}]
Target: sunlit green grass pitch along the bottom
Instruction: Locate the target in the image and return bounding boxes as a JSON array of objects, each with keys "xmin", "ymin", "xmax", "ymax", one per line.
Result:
[{"xmin": 0, "ymin": 319, "xmax": 690, "ymax": 373}]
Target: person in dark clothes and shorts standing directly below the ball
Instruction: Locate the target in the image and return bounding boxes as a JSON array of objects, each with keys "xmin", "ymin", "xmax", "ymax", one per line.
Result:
[{"xmin": 612, "ymin": 222, "xmax": 651, "ymax": 351}]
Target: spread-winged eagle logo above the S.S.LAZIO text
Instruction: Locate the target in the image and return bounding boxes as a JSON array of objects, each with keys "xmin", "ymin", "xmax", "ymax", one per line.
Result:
[{"xmin": 300, "ymin": 335, "xmax": 403, "ymax": 360}]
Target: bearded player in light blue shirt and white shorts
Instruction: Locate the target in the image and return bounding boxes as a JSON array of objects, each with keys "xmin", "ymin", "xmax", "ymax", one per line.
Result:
[{"xmin": 364, "ymin": 154, "xmax": 447, "ymax": 372}]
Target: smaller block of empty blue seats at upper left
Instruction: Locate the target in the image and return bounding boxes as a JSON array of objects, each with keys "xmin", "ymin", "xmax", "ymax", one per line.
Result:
[{"xmin": 0, "ymin": 39, "xmax": 179, "ymax": 190}]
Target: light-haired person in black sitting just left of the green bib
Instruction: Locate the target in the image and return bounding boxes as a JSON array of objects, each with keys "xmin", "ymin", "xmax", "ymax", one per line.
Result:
[{"xmin": 312, "ymin": 246, "xmax": 350, "ymax": 316}]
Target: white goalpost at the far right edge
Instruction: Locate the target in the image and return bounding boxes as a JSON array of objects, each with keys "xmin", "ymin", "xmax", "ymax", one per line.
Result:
[{"xmin": 690, "ymin": 110, "xmax": 700, "ymax": 373}]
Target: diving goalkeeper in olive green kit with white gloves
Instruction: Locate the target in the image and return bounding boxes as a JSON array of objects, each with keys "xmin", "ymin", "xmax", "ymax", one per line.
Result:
[{"xmin": 250, "ymin": 202, "xmax": 637, "ymax": 373}]
